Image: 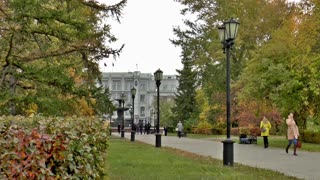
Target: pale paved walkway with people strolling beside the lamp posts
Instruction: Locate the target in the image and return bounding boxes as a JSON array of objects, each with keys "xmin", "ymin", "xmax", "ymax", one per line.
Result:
[{"xmin": 112, "ymin": 133, "xmax": 320, "ymax": 180}]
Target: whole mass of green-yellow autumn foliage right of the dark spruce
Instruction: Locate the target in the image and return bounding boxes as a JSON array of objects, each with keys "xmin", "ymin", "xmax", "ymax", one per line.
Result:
[{"xmin": 173, "ymin": 0, "xmax": 320, "ymax": 133}]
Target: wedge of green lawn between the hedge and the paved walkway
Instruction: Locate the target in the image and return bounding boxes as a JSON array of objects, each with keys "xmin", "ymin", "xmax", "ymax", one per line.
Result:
[{"xmin": 105, "ymin": 137, "xmax": 296, "ymax": 180}]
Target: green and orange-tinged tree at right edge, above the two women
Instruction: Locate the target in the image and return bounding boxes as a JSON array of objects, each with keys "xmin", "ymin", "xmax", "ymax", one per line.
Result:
[{"xmin": 238, "ymin": 1, "xmax": 320, "ymax": 128}]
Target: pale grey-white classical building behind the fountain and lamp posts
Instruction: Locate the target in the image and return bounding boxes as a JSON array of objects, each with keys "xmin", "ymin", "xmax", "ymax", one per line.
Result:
[{"xmin": 102, "ymin": 71, "xmax": 179, "ymax": 127}]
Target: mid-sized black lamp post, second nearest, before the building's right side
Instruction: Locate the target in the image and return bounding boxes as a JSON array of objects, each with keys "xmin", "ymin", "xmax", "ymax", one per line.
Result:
[{"xmin": 153, "ymin": 69, "xmax": 163, "ymax": 147}]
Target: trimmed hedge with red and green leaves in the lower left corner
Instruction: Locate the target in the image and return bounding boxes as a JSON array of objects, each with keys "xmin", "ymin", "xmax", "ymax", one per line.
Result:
[{"xmin": 0, "ymin": 116, "xmax": 109, "ymax": 179}]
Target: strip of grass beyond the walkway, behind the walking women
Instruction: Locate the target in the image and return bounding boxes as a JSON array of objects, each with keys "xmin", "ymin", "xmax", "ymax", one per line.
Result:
[{"xmin": 169, "ymin": 133, "xmax": 320, "ymax": 152}]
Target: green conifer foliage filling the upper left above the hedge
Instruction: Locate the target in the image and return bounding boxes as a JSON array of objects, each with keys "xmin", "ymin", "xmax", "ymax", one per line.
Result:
[{"xmin": 0, "ymin": 0, "xmax": 126, "ymax": 115}]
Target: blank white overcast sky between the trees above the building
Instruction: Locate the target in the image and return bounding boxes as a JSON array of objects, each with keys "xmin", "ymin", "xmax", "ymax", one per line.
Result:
[{"xmin": 99, "ymin": 0, "xmax": 183, "ymax": 75}]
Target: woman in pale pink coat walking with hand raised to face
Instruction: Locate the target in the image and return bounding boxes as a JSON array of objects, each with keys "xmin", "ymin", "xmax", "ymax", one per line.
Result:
[{"xmin": 286, "ymin": 113, "xmax": 299, "ymax": 156}]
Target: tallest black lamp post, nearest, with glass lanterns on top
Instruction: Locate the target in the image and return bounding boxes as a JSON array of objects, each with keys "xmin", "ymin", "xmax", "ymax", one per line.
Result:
[{"xmin": 218, "ymin": 18, "xmax": 240, "ymax": 166}]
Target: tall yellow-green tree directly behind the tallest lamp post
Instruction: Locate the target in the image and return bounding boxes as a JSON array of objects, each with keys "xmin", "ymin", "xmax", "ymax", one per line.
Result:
[{"xmin": 176, "ymin": 0, "xmax": 295, "ymax": 129}]
